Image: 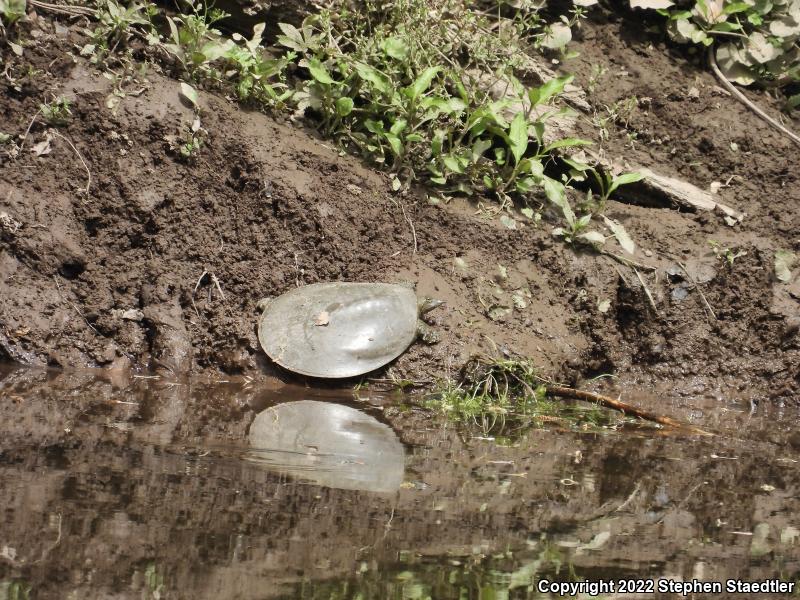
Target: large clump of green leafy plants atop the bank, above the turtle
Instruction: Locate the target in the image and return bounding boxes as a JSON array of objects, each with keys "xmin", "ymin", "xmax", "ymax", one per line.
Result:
[{"xmin": 278, "ymin": 0, "xmax": 589, "ymax": 203}]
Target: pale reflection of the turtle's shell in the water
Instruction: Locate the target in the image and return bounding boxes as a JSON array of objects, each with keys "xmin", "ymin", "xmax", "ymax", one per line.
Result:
[{"xmin": 247, "ymin": 400, "xmax": 405, "ymax": 492}]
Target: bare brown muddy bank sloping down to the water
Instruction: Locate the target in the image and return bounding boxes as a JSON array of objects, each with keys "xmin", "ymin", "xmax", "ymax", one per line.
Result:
[{"xmin": 0, "ymin": 8, "xmax": 800, "ymax": 400}]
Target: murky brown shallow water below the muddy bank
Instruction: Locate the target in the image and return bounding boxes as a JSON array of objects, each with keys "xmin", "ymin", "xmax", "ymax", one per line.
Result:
[{"xmin": 0, "ymin": 370, "xmax": 800, "ymax": 600}]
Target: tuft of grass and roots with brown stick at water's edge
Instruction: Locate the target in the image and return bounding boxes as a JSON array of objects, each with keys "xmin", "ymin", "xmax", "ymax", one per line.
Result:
[{"xmin": 425, "ymin": 356, "xmax": 611, "ymax": 439}]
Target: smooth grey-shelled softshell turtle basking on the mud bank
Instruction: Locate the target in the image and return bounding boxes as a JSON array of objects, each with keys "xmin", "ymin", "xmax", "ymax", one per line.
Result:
[{"xmin": 258, "ymin": 282, "xmax": 442, "ymax": 378}]
